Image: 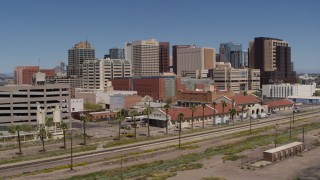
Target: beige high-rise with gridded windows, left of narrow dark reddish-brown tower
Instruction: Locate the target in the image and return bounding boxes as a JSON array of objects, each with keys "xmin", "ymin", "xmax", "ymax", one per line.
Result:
[{"xmin": 125, "ymin": 39, "xmax": 160, "ymax": 76}]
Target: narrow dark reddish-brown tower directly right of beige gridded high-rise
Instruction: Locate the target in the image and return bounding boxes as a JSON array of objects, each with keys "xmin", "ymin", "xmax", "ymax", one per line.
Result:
[{"xmin": 159, "ymin": 42, "xmax": 170, "ymax": 73}]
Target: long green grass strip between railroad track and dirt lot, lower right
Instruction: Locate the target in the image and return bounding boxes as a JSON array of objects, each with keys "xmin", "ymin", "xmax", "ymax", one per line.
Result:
[{"xmin": 70, "ymin": 123, "xmax": 320, "ymax": 180}]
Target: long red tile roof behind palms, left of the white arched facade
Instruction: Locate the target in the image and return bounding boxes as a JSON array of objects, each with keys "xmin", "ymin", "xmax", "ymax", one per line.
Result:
[{"xmin": 161, "ymin": 103, "xmax": 241, "ymax": 121}]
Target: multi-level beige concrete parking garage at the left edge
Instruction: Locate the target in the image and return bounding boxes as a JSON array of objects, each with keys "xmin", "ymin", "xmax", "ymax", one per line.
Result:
[{"xmin": 0, "ymin": 84, "xmax": 70, "ymax": 128}]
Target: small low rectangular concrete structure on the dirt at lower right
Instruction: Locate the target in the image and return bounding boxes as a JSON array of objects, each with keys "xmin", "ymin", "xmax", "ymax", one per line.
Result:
[{"xmin": 263, "ymin": 142, "xmax": 303, "ymax": 162}]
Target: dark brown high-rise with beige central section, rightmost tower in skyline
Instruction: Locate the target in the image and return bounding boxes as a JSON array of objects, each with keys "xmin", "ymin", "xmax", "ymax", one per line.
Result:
[{"xmin": 249, "ymin": 37, "xmax": 297, "ymax": 85}]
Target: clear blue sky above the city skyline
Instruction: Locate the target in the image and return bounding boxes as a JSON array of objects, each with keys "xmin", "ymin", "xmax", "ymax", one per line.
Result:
[{"xmin": 0, "ymin": 0, "xmax": 320, "ymax": 73}]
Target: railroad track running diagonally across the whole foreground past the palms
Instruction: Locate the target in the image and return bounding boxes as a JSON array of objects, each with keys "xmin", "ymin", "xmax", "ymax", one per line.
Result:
[{"xmin": 0, "ymin": 111, "xmax": 320, "ymax": 174}]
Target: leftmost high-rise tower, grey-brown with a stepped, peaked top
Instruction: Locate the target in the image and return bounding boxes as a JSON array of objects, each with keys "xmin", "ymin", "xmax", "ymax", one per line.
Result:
[{"xmin": 67, "ymin": 41, "xmax": 95, "ymax": 77}]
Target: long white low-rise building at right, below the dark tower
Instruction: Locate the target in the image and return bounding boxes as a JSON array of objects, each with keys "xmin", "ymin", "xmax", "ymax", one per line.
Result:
[{"xmin": 262, "ymin": 83, "xmax": 316, "ymax": 98}]
